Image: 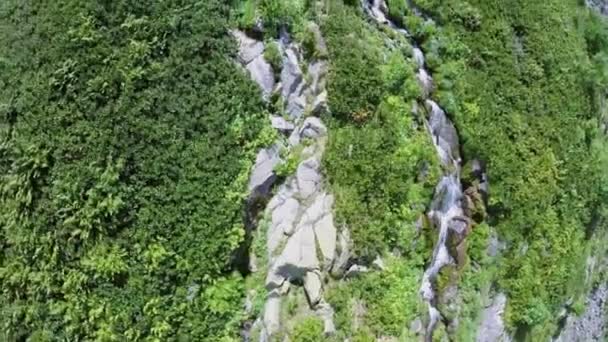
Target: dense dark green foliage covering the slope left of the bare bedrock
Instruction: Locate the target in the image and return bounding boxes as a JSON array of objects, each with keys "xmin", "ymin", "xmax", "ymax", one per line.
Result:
[{"xmin": 0, "ymin": 0, "xmax": 267, "ymax": 341}]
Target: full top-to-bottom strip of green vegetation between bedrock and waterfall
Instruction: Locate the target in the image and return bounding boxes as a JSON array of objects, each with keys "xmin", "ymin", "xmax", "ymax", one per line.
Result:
[{"xmin": 321, "ymin": 2, "xmax": 440, "ymax": 341}]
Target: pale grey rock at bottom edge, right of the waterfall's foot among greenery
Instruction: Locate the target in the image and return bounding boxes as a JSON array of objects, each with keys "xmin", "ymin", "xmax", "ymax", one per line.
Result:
[{"xmin": 476, "ymin": 293, "xmax": 510, "ymax": 342}]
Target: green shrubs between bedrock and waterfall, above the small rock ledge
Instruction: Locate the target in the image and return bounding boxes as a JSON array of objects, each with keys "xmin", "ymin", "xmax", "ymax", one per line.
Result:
[{"xmin": 321, "ymin": 0, "xmax": 439, "ymax": 259}]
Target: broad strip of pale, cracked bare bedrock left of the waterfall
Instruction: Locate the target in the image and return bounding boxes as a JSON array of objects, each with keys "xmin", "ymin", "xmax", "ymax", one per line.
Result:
[{"xmin": 235, "ymin": 24, "xmax": 340, "ymax": 341}]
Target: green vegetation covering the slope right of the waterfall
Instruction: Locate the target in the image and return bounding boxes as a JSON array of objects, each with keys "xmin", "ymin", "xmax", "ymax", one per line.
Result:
[{"xmin": 408, "ymin": 0, "xmax": 608, "ymax": 341}]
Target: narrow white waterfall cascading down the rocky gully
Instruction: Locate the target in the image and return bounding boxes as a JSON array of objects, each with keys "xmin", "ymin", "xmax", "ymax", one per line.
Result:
[{"xmin": 363, "ymin": 0, "xmax": 467, "ymax": 341}]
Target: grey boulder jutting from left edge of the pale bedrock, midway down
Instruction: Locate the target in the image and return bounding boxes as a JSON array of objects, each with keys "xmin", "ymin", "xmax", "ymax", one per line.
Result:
[{"xmin": 249, "ymin": 144, "xmax": 281, "ymax": 197}]
